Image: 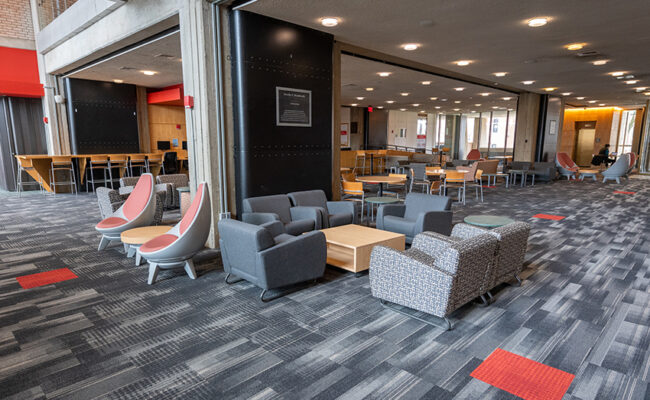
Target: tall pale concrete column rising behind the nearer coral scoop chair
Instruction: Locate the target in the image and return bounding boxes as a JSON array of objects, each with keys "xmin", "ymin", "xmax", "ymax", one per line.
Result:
[{"xmin": 179, "ymin": 0, "xmax": 222, "ymax": 248}]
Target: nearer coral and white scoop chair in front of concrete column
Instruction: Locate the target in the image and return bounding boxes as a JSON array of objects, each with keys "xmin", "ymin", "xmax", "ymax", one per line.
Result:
[{"xmin": 138, "ymin": 182, "xmax": 212, "ymax": 285}]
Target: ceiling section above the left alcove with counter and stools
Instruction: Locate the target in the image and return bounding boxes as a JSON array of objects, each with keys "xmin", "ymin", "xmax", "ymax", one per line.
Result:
[{"xmin": 70, "ymin": 32, "xmax": 183, "ymax": 88}]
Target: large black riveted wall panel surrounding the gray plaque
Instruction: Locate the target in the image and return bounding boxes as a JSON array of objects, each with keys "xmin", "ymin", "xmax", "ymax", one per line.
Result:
[{"xmin": 231, "ymin": 11, "xmax": 334, "ymax": 212}]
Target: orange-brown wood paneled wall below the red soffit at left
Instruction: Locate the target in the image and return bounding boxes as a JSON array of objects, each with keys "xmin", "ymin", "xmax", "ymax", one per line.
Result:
[{"xmin": 148, "ymin": 104, "xmax": 187, "ymax": 153}]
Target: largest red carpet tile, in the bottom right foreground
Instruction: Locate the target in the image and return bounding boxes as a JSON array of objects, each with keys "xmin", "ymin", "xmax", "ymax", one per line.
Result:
[{"xmin": 470, "ymin": 349, "xmax": 575, "ymax": 400}]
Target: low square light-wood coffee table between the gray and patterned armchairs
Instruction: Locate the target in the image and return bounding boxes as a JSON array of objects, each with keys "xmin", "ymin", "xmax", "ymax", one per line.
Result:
[{"xmin": 321, "ymin": 224, "xmax": 406, "ymax": 273}]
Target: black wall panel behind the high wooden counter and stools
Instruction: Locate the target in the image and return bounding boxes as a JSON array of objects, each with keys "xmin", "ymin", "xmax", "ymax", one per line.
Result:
[{"xmin": 65, "ymin": 78, "xmax": 140, "ymax": 154}]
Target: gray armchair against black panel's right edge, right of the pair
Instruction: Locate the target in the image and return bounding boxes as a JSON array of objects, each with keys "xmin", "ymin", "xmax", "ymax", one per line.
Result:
[{"xmin": 288, "ymin": 190, "xmax": 356, "ymax": 229}]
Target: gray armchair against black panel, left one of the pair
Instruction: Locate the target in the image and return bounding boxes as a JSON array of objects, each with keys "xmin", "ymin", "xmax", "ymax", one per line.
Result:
[{"xmin": 242, "ymin": 194, "xmax": 320, "ymax": 236}]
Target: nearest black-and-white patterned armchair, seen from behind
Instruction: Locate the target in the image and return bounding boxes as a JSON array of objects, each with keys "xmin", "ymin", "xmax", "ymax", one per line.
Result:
[{"xmin": 370, "ymin": 228, "xmax": 497, "ymax": 329}]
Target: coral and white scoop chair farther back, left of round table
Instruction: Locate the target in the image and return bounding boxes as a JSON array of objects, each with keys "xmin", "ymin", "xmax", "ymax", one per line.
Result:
[{"xmin": 95, "ymin": 174, "xmax": 156, "ymax": 250}]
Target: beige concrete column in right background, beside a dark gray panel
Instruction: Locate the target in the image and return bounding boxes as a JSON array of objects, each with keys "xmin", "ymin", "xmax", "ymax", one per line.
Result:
[{"xmin": 513, "ymin": 92, "xmax": 536, "ymax": 162}]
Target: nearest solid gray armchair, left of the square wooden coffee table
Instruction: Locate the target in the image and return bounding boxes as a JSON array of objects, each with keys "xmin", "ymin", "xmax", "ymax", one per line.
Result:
[{"xmin": 218, "ymin": 219, "xmax": 327, "ymax": 301}]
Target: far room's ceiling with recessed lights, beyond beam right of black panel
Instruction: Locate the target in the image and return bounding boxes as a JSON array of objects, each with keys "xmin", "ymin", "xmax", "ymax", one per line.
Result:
[{"xmin": 341, "ymin": 55, "xmax": 517, "ymax": 113}]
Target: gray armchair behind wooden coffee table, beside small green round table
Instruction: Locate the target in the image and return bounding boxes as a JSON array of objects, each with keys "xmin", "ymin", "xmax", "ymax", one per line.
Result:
[{"xmin": 377, "ymin": 193, "xmax": 453, "ymax": 243}]
